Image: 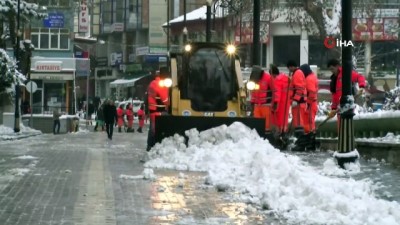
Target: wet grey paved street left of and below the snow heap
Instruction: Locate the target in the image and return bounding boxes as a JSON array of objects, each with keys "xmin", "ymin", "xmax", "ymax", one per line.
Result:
[{"xmin": 0, "ymin": 127, "xmax": 281, "ymax": 225}]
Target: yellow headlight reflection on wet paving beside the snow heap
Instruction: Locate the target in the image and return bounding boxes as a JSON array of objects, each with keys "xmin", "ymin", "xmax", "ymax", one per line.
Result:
[{"xmin": 150, "ymin": 170, "xmax": 281, "ymax": 225}]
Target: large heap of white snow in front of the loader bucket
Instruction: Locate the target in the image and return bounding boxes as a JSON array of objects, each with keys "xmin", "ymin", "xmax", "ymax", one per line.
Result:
[{"xmin": 145, "ymin": 122, "xmax": 400, "ymax": 225}]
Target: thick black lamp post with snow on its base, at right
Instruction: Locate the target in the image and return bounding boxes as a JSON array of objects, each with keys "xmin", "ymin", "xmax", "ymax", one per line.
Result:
[{"xmin": 334, "ymin": 0, "xmax": 359, "ymax": 169}]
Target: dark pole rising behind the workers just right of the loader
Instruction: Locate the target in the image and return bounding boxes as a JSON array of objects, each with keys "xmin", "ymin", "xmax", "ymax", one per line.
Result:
[{"xmin": 253, "ymin": 0, "xmax": 261, "ymax": 66}]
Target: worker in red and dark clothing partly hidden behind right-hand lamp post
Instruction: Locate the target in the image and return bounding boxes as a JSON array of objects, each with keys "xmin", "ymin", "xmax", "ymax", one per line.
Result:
[{"xmin": 328, "ymin": 59, "xmax": 366, "ymax": 128}]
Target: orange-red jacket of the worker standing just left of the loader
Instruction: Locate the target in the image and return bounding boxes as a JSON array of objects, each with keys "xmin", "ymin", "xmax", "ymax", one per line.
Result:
[{"xmin": 147, "ymin": 77, "xmax": 169, "ymax": 113}]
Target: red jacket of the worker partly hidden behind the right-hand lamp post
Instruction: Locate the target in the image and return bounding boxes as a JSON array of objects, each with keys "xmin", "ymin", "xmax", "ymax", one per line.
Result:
[{"xmin": 331, "ymin": 67, "xmax": 365, "ymax": 110}]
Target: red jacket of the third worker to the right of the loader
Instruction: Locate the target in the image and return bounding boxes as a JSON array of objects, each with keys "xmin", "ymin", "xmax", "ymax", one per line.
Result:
[{"xmin": 289, "ymin": 69, "xmax": 307, "ymax": 103}]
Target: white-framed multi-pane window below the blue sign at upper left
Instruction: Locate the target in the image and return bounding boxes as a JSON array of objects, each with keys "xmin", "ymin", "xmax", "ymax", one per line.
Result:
[{"xmin": 31, "ymin": 28, "xmax": 69, "ymax": 50}]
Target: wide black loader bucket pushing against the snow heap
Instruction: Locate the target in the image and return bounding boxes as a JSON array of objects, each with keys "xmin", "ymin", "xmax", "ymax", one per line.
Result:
[{"xmin": 155, "ymin": 115, "xmax": 265, "ymax": 142}]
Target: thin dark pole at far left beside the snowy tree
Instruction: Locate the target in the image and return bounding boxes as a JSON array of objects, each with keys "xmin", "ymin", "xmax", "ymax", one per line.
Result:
[{"xmin": 11, "ymin": 0, "xmax": 21, "ymax": 133}]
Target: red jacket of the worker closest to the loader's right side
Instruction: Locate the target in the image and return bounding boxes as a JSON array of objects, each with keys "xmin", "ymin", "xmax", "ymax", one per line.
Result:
[{"xmin": 250, "ymin": 72, "xmax": 272, "ymax": 105}]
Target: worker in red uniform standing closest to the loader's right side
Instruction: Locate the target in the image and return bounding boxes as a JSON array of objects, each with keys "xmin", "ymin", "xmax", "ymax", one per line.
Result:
[{"xmin": 250, "ymin": 67, "xmax": 272, "ymax": 137}]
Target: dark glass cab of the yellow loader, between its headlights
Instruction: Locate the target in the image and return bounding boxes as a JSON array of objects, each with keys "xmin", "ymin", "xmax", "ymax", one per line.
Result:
[{"xmin": 178, "ymin": 44, "xmax": 239, "ymax": 112}]
